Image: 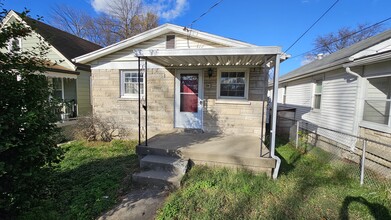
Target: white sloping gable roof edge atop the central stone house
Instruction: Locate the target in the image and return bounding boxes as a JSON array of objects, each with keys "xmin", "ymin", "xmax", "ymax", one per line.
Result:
[{"xmin": 74, "ymin": 24, "xmax": 255, "ymax": 63}]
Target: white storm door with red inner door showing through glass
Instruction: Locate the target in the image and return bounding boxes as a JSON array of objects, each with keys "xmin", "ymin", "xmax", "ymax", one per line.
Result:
[{"xmin": 175, "ymin": 70, "xmax": 203, "ymax": 129}]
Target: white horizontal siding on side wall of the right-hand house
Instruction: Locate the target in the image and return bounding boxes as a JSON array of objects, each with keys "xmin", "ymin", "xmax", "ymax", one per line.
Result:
[{"xmin": 280, "ymin": 69, "xmax": 358, "ymax": 146}]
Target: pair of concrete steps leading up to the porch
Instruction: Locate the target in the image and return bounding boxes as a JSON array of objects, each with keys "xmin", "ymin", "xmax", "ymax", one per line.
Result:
[{"xmin": 132, "ymin": 154, "xmax": 188, "ymax": 188}]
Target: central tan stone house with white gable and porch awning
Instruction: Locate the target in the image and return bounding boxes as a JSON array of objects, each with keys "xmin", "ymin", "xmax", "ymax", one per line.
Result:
[{"xmin": 74, "ymin": 24, "xmax": 285, "ymax": 137}]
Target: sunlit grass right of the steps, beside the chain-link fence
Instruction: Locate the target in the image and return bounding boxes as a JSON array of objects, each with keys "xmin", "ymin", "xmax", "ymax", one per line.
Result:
[{"xmin": 157, "ymin": 140, "xmax": 391, "ymax": 219}]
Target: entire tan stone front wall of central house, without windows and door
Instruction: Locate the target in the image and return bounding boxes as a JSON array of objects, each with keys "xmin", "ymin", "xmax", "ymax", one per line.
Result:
[{"xmin": 92, "ymin": 68, "xmax": 267, "ymax": 137}]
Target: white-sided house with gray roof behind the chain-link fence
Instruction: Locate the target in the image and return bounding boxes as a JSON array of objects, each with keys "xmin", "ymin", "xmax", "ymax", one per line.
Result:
[{"xmin": 278, "ymin": 30, "xmax": 391, "ymax": 176}]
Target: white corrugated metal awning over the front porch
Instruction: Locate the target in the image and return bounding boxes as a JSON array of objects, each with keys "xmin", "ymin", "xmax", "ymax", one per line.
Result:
[{"xmin": 136, "ymin": 47, "xmax": 281, "ymax": 68}]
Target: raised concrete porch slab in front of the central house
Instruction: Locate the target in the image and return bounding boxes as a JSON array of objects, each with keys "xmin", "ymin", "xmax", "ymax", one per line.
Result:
[{"xmin": 137, "ymin": 129, "xmax": 275, "ymax": 175}]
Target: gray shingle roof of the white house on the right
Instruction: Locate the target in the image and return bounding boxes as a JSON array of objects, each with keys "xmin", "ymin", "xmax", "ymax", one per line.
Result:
[{"xmin": 279, "ymin": 30, "xmax": 391, "ymax": 82}]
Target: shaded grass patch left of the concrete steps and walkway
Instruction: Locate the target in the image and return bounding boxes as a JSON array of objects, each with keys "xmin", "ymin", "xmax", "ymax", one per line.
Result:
[{"xmin": 19, "ymin": 140, "xmax": 138, "ymax": 219}]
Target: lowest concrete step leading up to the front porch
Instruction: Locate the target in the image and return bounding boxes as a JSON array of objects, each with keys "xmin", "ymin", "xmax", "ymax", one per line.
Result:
[{"xmin": 132, "ymin": 170, "xmax": 183, "ymax": 188}]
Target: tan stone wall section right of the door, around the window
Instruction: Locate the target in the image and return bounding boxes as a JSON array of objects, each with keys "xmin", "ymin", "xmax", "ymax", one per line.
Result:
[{"xmin": 203, "ymin": 68, "xmax": 267, "ymax": 136}]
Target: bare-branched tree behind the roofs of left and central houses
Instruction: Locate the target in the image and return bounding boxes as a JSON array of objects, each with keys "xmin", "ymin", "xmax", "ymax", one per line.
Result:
[{"xmin": 50, "ymin": 0, "xmax": 159, "ymax": 46}]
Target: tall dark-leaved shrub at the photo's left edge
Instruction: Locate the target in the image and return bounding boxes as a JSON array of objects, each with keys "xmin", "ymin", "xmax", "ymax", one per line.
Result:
[{"xmin": 0, "ymin": 9, "xmax": 63, "ymax": 219}]
